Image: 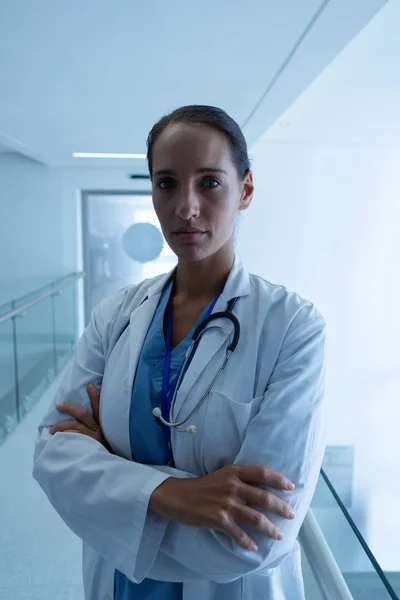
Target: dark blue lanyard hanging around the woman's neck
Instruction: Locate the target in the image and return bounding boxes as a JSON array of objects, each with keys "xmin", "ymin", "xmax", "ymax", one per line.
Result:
[{"xmin": 161, "ymin": 288, "xmax": 223, "ymax": 466}]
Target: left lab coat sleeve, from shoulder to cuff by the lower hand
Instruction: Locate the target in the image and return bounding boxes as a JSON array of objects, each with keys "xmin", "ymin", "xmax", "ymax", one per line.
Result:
[{"xmin": 33, "ymin": 297, "xmax": 192, "ymax": 579}]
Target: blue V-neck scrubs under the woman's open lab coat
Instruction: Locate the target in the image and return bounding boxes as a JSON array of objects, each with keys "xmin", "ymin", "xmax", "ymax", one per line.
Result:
[{"xmin": 114, "ymin": 281, "xmax": 209, "ymax": 600}]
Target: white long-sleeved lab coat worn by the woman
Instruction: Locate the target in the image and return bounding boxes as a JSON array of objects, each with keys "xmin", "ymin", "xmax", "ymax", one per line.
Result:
[{"xmin": 34, "ymin": 258, "xmax": 325, "ymax": 600}]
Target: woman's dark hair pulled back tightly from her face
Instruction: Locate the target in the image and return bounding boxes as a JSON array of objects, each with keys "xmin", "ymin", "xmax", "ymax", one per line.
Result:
[{"xmin": 147, "ymin": 105, "xmax": 250, "ymax": 179}]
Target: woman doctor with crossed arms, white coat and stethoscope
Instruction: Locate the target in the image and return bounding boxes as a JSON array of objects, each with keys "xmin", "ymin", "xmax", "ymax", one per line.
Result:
[{"xmin": 34, "ymin": 106, "xmax": 324, "ymax": 600}]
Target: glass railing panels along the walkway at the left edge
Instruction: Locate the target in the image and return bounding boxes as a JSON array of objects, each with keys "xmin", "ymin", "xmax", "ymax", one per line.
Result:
[{"xmin": 0, "ymin": 273, "xmax": 83, "ymax": 444}]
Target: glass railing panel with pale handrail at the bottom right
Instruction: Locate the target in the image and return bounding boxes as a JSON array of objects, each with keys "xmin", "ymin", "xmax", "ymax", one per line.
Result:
[{"xmin": 299, "ymin": 470, "xmax": 399, "ymax": 600}]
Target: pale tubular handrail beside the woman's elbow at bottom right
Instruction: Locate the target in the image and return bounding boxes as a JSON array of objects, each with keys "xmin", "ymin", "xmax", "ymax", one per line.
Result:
[{"xmin": 298, "ymin": 509, "xmax": 354, "ymax": 600}]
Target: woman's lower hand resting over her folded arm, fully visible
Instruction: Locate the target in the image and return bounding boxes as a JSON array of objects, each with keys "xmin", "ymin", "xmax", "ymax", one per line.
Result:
[{"xmin": 149, "ymin": 465, "xmax": 294, "ymax": 551}]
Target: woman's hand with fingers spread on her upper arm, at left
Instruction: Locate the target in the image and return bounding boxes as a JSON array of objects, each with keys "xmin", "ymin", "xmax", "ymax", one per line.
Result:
[{"xmin": 50, "ymin": 384, "xmax": 111, "ymax": 452}]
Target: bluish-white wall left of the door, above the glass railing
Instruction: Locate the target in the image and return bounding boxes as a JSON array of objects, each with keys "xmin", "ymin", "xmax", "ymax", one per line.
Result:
[{"xmin": 0, "ymin": 154, "xmax": 67, "ymax": 279}]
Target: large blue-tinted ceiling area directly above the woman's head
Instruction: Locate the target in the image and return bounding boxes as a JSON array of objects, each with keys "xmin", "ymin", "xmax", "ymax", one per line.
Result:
[{"xmin": 0, "ymin": 0, "xmax": 385, "ymax": 169}]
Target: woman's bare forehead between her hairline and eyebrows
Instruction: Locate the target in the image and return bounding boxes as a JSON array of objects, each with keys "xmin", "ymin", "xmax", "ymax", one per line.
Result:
[{"xmin": 153, "ymin": 123, "xmax": 234, "ymax": 171}]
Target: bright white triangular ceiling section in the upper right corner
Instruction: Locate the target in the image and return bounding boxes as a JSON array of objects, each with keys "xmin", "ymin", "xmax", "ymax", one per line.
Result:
[{"xmin": 263, "ymin": 0, "xmax": 400, "ymax": 147}]
